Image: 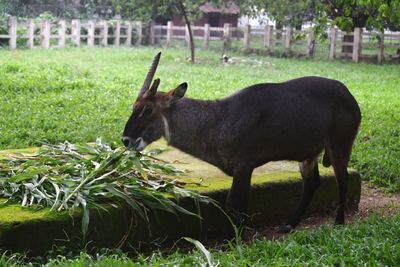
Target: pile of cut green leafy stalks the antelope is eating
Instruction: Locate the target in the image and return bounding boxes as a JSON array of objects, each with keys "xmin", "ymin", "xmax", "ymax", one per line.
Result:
[{"xmin": 0, "ymin": 139, "xmax": 215, "ymax": 238}]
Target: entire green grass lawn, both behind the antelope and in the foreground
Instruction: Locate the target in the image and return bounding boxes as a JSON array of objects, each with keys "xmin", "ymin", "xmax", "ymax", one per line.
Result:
[{"xmin": 0, "ymin": 48, "xmax": 400, "ymax": 266}]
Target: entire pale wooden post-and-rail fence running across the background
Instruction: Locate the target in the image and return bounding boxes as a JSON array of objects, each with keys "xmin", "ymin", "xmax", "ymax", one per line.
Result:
[{"xmin": 0, "ymin": 17, "xmax": 400, "ymax": 63}]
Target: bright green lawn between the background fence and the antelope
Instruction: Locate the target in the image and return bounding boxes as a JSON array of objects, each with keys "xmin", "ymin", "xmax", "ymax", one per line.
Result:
[{"xmin": 0, "ymin": 48, "xmax": 400, "ymax": 191}]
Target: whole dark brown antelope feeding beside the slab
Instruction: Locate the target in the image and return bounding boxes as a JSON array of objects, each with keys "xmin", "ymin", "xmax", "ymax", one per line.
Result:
[{"xmin": 122, "ymin": 53, "xmax": 361, "ymax": 231}]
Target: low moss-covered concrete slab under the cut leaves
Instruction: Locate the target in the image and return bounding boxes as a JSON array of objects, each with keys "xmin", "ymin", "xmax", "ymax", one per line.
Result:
[{"xmin": 0, "ymin": 141, "xmax": 361, "ymax": 255}]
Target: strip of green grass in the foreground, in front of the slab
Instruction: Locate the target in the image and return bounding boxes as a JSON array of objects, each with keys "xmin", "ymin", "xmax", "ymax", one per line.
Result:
[{"xmin": 0, "ymin": 215, "xmax": 400, "ymax": 266}]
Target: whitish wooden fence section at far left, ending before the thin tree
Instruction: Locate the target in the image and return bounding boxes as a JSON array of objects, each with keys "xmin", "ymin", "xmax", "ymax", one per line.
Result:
[{"xmin": 0, "ymin": 17, "xmax": 143, "ymax": 49}]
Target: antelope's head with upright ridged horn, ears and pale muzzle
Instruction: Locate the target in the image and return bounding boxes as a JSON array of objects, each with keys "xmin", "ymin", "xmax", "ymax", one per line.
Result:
[{"xmin": 122, "ymin": 52, "xmax": 187, "ymax": 151}]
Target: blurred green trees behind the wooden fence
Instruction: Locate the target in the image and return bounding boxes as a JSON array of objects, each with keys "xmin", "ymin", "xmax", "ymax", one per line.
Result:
[{"xmin": 0, "ymin": 0, "xmax": 400, "ymax": 31}]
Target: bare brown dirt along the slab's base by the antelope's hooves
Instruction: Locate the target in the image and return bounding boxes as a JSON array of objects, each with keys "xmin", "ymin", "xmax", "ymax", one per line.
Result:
[{"xmin": 256, "ymin": 182, "xmax": 400, "ymax": 239}]
